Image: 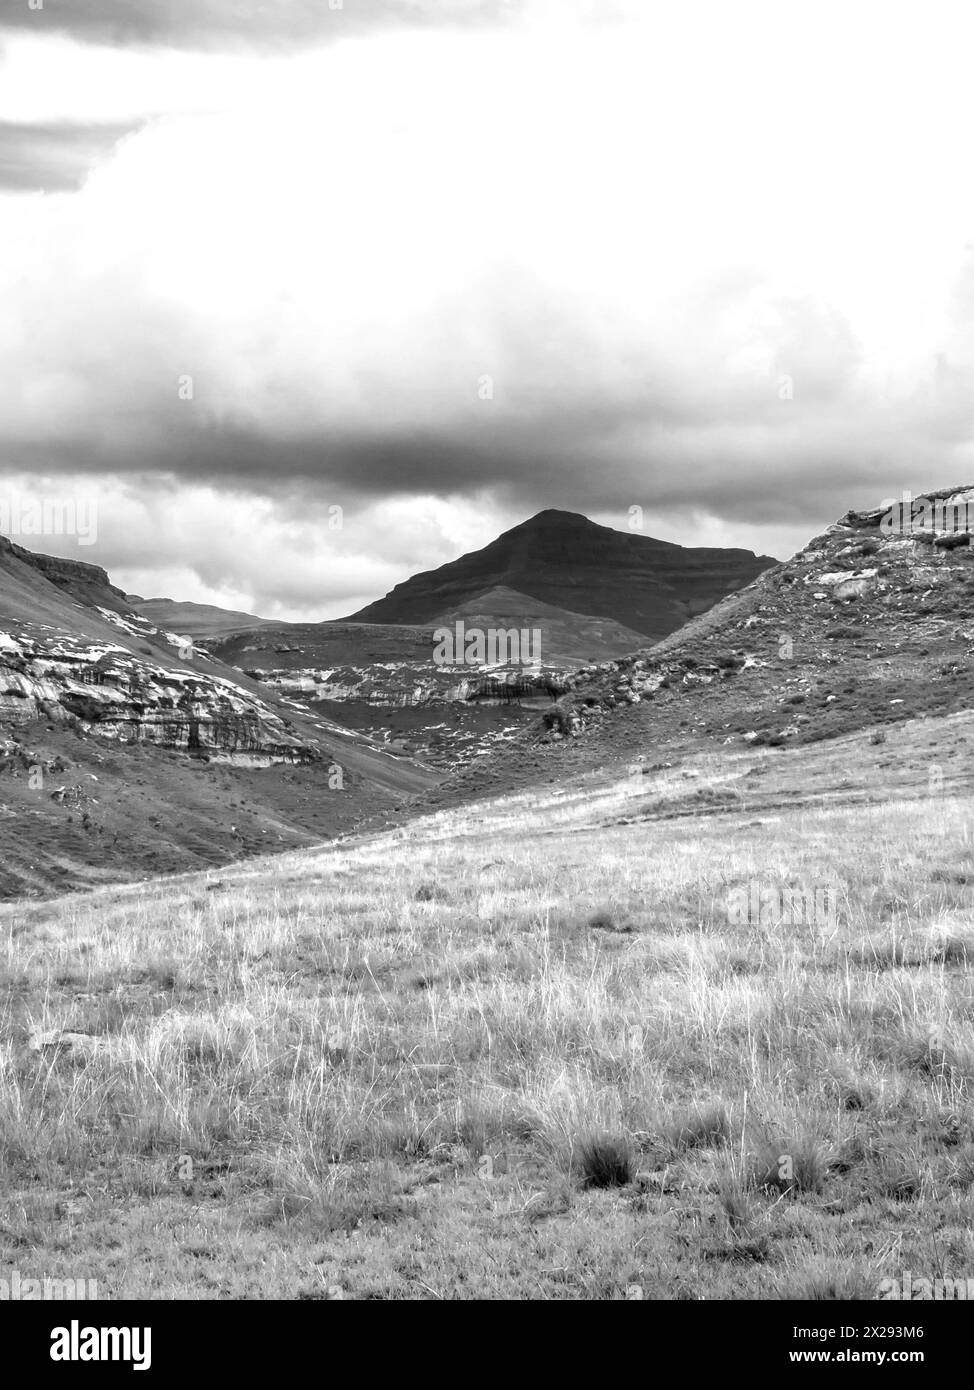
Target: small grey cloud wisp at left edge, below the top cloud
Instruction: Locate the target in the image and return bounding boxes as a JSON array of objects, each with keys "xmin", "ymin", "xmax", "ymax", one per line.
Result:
[{"xmin": 0, "ymin": 121, "xmax": 139, "ymax": 193}]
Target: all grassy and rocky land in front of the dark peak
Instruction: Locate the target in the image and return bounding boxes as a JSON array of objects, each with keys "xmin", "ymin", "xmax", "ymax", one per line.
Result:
[{"xmin": 0, "ymin": 491, "xmax": 974, "ymax": 1300}]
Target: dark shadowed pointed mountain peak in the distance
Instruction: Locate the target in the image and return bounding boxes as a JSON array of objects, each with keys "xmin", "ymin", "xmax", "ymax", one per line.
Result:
[{"xmin": 341, "ymin": 510, "xmax": 777, "ymax": 641}]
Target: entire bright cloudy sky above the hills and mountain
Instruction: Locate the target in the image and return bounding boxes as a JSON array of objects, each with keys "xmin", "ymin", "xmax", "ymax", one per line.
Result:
[{"xmin": 0, "ymin": 0, "xmax": 974, "ymax": 619}]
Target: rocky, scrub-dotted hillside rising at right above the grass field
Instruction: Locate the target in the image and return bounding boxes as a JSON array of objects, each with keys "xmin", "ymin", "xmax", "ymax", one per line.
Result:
[{"xmin": 525, "ymin": 488, "xmax": 974, "ymax": 746}]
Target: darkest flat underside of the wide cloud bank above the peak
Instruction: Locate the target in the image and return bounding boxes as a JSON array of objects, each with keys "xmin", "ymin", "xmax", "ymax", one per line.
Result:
[{"xmin": 7, "ymin": 364, "xmax": 974, "ymax": 543}]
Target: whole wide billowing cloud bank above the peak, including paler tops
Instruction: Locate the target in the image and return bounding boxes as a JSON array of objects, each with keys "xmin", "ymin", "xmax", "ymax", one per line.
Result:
[{"xmin": 6, "ymin": 211, "xmax": 974, "ymax": 534}]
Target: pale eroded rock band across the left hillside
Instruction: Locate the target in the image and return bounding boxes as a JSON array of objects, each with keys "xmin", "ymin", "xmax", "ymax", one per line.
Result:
[{"xmin": 0, "ymin": 626, "xmax": 315, "ymax": 766}]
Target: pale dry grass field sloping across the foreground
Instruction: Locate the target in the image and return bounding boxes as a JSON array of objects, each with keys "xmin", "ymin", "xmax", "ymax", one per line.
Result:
[{"xmin": 0, "ymin": 720, "xmax": 974, "ymax": 1300}]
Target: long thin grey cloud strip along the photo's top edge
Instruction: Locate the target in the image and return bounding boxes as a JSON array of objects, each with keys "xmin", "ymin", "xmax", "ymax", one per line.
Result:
[{"xmin": 0, "ymin": 0, "xmax": 521, "ymax": 49}]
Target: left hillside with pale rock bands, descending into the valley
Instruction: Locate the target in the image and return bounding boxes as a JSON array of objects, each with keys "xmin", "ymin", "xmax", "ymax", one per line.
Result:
[{"xmin": 0, "ymin": 538, "xmax": 438, "ymax": 897}]
